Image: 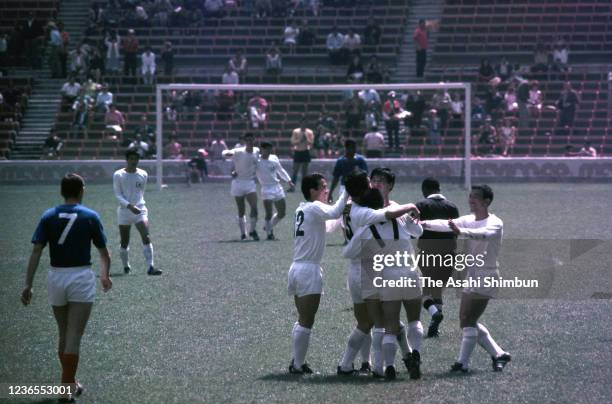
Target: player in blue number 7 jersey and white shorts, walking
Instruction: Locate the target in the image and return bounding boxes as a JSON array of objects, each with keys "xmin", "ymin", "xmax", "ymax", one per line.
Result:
[{"xmin": 21, "ymin": 174, "xmax": 113, "ymax": 402}]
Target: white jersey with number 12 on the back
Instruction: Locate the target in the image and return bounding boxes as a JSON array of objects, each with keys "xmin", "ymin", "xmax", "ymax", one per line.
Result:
[{"xmin": 293, "ymin": 192, "xmax": 347, "ymax": 265}]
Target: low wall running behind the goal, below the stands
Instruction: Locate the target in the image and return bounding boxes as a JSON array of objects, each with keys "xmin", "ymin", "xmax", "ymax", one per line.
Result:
[{"xmin": 0, "ymin": 157, "xmax": 612, "ymax": 184}]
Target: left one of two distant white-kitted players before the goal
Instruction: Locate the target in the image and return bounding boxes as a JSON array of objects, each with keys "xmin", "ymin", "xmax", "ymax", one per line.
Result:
[{"xmin": 222, "ymin": 132, "xmax": 259, "ymax": 241}]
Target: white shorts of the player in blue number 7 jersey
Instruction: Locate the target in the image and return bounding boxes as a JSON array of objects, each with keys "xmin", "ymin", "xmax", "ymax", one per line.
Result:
[{"xmin": 47, "ymin": 267, "xmax": 96, "ymax": 306}]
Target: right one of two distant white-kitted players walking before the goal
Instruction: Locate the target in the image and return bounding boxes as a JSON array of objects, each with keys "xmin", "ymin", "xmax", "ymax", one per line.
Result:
[{"xmin": 257, "ymin": 142, "xmax": 294, "ymax": 240}]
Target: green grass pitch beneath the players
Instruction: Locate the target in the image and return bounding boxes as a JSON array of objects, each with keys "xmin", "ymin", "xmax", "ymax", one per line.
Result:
[{"xmin": 0, "ymin": 183, "xmax": 612, "ymax": 403}]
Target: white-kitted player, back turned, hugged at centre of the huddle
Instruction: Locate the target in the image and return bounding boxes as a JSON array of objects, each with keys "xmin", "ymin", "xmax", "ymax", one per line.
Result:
[{"xmin": 343, "ymin": 188, "xmax": 423, "ymax": 380}]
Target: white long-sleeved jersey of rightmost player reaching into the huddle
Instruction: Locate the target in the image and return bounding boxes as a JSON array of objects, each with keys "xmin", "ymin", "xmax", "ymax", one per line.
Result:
[{"xmin": 426, "ymin": 213, "xmax": 504, "ymax": 270}]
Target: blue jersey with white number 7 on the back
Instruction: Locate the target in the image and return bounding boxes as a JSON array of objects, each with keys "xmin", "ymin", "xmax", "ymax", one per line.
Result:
[{"xmin": 32, "ymin": 205, "xmax": 106, "ymax": 267}]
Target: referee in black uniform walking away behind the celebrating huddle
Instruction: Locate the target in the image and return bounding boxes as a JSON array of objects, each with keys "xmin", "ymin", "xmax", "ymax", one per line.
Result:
[{"xmin": 416, "ymin": 177, "xmax": 459, "ymax": 338}]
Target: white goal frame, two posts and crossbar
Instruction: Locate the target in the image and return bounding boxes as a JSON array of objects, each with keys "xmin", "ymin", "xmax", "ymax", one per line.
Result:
[{"xmin": 155, "ymin": 83, "xmax": 472, "ymax": 190}]
